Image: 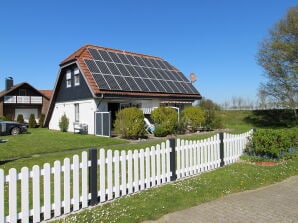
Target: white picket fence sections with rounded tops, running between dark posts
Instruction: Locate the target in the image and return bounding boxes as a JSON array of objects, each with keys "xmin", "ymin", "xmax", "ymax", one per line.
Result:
[{"xmin": 0, "ymin": 131, "xmax": 252, "ymax": 223}]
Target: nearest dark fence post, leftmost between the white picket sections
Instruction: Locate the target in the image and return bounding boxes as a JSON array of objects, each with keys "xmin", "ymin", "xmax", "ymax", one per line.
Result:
[{"xmin": 89, "ymin": 148, "xmax": 97, "ymax": 206}]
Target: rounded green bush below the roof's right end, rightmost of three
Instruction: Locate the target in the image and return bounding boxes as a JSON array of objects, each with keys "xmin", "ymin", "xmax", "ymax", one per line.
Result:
[{"xmin": 181, "ymin": 106, "xmax": 205, "ymax": 132}]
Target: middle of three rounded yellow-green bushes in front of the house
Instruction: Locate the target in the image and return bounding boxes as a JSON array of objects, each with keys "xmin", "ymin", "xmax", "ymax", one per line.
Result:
[{"xmin": 151, "ymin": 107, "xmax": 178, "ymax": 134}]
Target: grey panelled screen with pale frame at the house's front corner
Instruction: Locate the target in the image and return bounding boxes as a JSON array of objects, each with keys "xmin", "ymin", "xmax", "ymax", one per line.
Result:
[{"xmin": 95, "ymin": 112, "xmax": 111, "ymax": 137}]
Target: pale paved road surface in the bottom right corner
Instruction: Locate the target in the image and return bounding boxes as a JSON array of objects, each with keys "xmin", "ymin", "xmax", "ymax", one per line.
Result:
[{"xmin": 143, "ymin": 176, "xmax": 298, "ymax": 223}]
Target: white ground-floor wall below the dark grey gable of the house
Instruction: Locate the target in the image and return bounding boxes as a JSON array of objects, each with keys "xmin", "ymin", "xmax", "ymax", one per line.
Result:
[{"xmin": 49, "ymin": 100, "xmax": 96, "ymax": 134}]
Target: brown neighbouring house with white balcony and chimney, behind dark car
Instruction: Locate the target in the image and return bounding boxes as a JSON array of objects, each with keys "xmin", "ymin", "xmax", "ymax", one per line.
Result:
[{"xmin": 0, "ymin": 77, "xmax": 52, "ymax": 122}]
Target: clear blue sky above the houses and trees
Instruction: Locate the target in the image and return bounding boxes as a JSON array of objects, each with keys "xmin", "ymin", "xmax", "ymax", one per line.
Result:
[{"xmin": 0, "ymin": 0, "xmax": 297, "ymax": 103}]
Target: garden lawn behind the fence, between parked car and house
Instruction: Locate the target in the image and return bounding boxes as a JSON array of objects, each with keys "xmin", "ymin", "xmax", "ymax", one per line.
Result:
[{"xmin": 0, "ymin": 128, "xmax": 127, "ymax": 160}]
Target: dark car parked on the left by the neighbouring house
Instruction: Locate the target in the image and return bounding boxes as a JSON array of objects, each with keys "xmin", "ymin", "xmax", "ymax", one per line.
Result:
[{"xmin": 0, "ymin": 120, "xmax": 28, "ymax": 135}]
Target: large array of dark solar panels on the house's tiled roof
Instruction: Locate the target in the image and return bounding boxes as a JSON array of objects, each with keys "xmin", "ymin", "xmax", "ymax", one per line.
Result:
[{"xmin": 84, "ymin": 48, "xmax": 199, "ymax": 94}]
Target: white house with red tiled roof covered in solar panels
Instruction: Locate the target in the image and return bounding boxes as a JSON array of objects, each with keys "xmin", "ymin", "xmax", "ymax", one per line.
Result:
[{"xmin": 45, "ymin": 45, "xmax": 201, "ymax": 135}]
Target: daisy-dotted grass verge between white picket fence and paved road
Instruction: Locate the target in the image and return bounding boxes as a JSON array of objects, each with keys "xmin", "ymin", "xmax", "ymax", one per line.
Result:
[{"xmin": 54, "ymin": 156, "xmax": 298, "ymax": 223}]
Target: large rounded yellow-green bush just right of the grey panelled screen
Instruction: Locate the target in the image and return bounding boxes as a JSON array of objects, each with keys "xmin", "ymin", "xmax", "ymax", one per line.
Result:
[{"xmin": 114, "ymin": 107, "xmax": 145, "ymax": 139}]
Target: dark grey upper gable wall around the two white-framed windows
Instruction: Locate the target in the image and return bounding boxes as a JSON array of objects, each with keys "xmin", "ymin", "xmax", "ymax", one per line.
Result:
[{"xmin": 56, "ymin": 65, "xmax": 93, "ymax": 102}]
